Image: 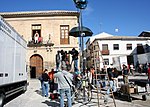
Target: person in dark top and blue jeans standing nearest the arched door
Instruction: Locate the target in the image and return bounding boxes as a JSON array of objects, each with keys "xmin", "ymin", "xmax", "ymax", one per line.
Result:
[{"xmin": 42, "ymin": 69, "xmax": 49, "ymax": 97}]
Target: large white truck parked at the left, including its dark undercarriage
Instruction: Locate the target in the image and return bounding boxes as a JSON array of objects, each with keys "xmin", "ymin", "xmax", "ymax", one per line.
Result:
[{"xmin": 0, "ymin": 16, "xmax": 27, "ymax": 107}]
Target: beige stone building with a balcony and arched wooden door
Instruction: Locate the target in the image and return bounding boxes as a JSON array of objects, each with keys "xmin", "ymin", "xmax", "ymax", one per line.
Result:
[{"xmin": 0, "ymin": 11, "xmax": 79, "ymax": 78}]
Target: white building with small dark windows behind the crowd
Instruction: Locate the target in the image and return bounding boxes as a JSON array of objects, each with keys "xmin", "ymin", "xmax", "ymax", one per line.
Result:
[{"xmin": 86, "ymin": 32, "xmax": 150, "ymax": 69}]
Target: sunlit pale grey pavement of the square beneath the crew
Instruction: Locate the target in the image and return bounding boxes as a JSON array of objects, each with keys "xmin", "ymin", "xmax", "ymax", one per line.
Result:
[{"xmin": 4, "ymin": 75, "xmax": 150, "ymax": 107}]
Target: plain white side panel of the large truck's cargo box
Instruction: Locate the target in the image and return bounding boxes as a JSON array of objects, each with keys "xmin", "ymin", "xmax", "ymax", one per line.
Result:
[{"xmin": 0, "ymin": 17, "xmax": 27, "ymax": 85}]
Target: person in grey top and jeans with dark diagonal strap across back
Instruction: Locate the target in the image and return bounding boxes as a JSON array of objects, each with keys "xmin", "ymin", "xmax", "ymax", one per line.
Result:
[{"xmin": 54, "ymin": 66, "xmax": 73, "ymax": 107}]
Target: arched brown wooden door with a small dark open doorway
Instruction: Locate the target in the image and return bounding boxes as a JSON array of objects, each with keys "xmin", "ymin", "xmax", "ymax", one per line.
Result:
[{"xmin": 30, "ymin": 54, "xmax": 43, "ymax": 78}]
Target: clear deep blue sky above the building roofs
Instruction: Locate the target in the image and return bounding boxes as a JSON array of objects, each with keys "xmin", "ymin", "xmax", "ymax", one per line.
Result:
[{"xmin": 0, "ymin": 0, "xmax": 150, "ymax": 36}]
